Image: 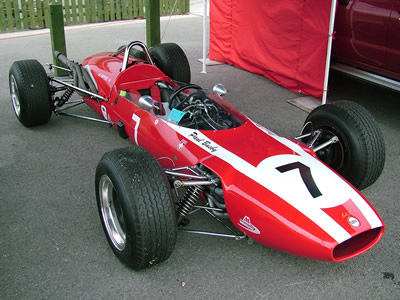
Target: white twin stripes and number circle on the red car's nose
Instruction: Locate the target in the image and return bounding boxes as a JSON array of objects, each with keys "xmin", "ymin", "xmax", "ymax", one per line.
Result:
[{"xmin": 167, "ymin": 123, "xmax": 382, "ymax": 243}]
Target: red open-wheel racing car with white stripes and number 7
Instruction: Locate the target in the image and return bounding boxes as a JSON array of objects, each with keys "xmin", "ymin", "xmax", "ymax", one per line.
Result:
[{"xmin": 9, "ymin": 41, "xmax": 385, "ymax": 270}]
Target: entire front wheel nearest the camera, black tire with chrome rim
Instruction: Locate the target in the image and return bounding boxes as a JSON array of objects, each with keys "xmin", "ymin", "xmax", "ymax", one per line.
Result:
[{"xmin": 95, "ymin": 147, "xmax": 177, "ymax": 270}]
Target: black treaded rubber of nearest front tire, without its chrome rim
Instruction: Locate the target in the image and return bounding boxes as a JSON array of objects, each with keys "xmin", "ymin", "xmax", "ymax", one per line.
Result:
[{"xmin": 96, "ymin": 147, "xmax": 177, "ymax": 270}]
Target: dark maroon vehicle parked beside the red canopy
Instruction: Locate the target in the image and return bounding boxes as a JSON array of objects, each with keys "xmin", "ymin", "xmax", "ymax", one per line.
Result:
[{"xmin": 332, "ymin": 0, "xmax": 400, "ymax": 86}]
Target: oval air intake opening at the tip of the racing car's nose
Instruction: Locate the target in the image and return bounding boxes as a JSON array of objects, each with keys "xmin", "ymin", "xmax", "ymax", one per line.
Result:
[{"xmin": 333, "ymin": 227, "xmax": 383, "ymax": 261}]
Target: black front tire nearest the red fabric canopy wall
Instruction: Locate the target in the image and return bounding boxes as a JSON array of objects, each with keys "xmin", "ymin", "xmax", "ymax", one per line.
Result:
[{"xmin": 303, "ymin": 101, "xmax": 386, "ymax": 190}]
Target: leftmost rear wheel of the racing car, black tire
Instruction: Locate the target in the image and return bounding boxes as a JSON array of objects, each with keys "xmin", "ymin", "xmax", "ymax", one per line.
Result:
[{"xmin": 9, "ymin": 59, "xmax": 53, "ymax": 127}]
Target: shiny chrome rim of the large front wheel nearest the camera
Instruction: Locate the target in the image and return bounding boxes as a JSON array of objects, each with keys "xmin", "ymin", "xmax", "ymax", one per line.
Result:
[{"xmin": 99, "ymin": 175, "xmax": 126, "ymax": 251}]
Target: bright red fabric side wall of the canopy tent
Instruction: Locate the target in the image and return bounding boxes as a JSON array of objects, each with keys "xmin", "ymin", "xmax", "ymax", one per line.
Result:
[{"xmin": 209, "ymin": 0, "xmax": 331, "ymax": 98}]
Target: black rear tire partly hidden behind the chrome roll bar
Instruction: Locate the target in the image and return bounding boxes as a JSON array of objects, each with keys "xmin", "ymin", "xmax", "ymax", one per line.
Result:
[{"xmin": 150, "ymin": 43, "xmax": 191, "ymax": 83}]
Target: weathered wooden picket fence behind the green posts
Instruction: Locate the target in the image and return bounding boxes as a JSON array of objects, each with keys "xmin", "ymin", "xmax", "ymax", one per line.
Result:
[{"xmin": 0, "ymin": 0, "xmax": 189, "ymax": 31}]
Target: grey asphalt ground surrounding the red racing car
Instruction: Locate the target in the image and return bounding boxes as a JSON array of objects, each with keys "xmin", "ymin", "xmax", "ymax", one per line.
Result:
[{"xmin": 0, "ymin": 8, "xmax": 400, "ymax": 299}]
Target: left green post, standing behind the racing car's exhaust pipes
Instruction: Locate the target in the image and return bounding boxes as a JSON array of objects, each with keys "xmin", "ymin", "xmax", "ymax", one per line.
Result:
[{"xmin": 49, "ymin": 0, "xmax": 69, "ymax": 76}]
